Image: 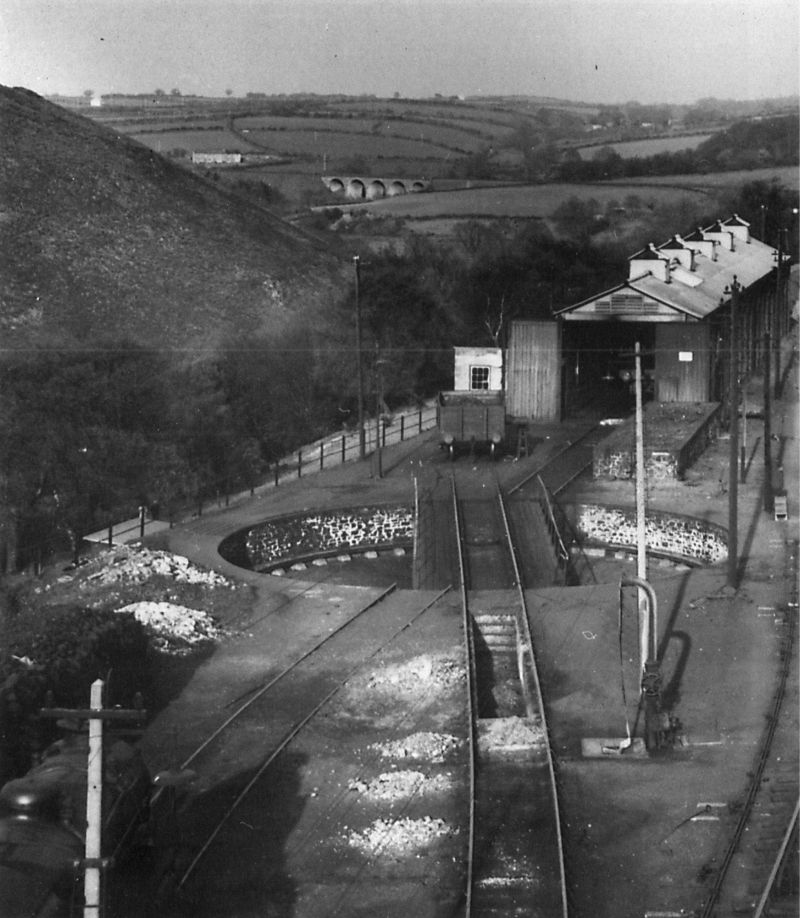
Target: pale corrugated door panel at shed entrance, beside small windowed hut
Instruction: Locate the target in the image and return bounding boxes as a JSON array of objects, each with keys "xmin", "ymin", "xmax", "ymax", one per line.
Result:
[{"xmin": 506, "ymin": 321, "xmax": 561, "ymax": 421}]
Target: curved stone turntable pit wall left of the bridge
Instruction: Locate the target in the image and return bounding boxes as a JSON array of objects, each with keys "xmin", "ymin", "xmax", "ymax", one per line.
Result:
[{"xmin": 245, "ymin": 506, "xmax": 414, "ymax": 570}]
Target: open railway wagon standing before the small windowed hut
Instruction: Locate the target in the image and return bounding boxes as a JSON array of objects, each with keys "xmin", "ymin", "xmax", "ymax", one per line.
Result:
[{"xmin": 439, "ymin": 390, "xmax": 506, "ymax": 459}]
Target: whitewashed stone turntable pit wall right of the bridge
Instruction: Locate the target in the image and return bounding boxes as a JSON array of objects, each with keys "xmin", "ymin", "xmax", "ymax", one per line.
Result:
[{"xmin": 571, "ymin": 504, "xmax": 728, "ymax": 564}]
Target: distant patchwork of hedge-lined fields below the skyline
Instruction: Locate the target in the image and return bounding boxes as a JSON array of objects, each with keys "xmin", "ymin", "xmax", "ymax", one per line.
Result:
[{"xmin": 93, "ymin": 97, "xmax": 798, "ymax": 233}]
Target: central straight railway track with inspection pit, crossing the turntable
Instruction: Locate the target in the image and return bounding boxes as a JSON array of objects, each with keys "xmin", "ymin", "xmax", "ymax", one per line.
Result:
[{"xmin": 452, "ymin": 477, "xmax": 567, "ymax": 918}]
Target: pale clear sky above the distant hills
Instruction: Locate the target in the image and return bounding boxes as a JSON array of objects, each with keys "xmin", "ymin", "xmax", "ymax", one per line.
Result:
[{"xmin": 0, "ymin": 0, "xmax": 800, "ymax": 104}]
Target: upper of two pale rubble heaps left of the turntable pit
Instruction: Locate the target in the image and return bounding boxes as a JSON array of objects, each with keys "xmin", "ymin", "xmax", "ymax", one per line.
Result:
[{"xmin": 81, "ymin": 545, "xmax": 234, "ymax": 589}]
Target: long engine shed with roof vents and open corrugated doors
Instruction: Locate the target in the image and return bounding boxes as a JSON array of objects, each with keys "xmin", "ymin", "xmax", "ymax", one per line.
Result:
[{"xmin": 507, "ymin": 215, "xmax": 789, "ymax": 420}]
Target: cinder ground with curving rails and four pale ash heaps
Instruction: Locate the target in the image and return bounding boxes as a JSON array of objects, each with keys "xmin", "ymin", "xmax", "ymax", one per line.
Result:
[{"xmin": 151, "ymin": 591, "xmax": 466, "ymax": 918}]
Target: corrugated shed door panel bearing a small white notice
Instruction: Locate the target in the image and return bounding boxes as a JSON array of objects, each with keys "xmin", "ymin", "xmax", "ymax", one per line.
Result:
[{"xmin": 655, "ymin": 322, "xmax": 711, "ymax": 402}]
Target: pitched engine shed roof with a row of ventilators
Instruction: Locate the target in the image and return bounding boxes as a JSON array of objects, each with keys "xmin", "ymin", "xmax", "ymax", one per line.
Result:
[{"xmin": 555, "ymin": 217, "xmax": 776, "ymax": 322}]
